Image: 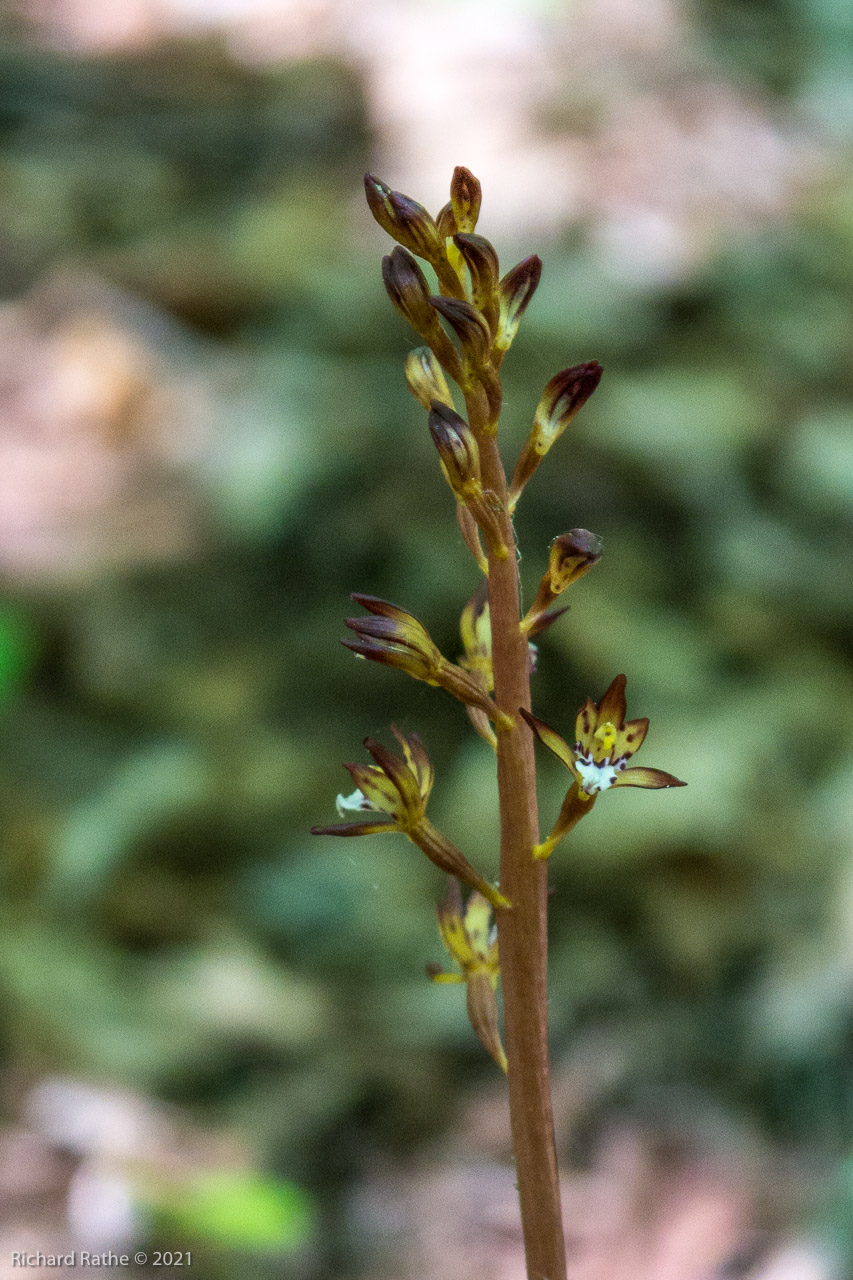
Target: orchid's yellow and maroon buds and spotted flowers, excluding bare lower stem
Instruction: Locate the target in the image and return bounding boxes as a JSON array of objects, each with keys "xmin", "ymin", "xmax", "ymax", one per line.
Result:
[{"xmin": 308, "ymin": 168, "xmax": 684, "ymax": 1085}]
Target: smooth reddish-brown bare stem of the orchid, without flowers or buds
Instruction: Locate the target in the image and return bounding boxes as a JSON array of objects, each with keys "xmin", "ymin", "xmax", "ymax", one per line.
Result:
[{"xmin": 466, "ymin": 396, "xmax": 566, "ymax": 1280}]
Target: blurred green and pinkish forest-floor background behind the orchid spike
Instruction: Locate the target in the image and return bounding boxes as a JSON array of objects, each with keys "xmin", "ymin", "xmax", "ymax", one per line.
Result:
[{"xmin": 0, "ymin": 0, "xmax": 853, "ymax": 1280}]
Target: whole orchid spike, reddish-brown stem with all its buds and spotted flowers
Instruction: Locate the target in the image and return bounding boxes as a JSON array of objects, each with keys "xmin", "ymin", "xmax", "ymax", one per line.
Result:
[{"xmin": 314, "ymin": 168, "xmax": 684, "ymax": 1280}]
